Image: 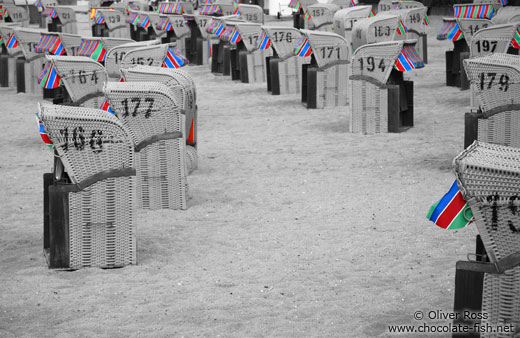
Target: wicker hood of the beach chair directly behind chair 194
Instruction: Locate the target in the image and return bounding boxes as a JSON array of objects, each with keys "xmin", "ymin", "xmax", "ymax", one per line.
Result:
[{"xmin": 352, "ymin": 13, "xmax": 400, "ymax": 50}]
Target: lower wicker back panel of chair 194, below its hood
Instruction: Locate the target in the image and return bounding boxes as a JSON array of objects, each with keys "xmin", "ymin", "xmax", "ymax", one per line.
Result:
[{"xmin": 349, "ymin": 80, "xmax": 388, "ymax": 134}]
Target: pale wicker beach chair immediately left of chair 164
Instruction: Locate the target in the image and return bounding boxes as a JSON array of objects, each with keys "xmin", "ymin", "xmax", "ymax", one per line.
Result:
[{"xmin": 13, "ymin": 27, "xmax": 43, "ymax": 95}]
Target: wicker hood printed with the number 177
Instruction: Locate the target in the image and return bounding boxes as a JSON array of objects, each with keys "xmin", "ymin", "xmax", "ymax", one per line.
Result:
[{"xmin": 104, "ymin": 82, "xmax": 183, "ymax": 145}]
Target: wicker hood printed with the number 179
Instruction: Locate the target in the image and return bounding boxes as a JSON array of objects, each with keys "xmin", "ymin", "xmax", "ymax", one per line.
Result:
[{"xmin": 464, "ymin": 54, "xmax": 520, "ymax": 115}]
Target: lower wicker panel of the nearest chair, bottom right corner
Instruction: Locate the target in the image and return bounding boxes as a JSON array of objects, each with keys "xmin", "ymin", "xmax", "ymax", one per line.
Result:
[{"xmin": 481, "ymin": 267, "xmax": 520, "ymax": 338}]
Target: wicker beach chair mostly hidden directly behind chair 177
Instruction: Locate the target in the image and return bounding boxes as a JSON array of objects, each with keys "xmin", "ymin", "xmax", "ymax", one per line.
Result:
[{"xmin": 121, "ymin": 65, "xmax": 198, "ymax": 174}]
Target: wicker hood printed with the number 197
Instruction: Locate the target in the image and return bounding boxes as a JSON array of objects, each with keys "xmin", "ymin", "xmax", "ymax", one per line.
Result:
[{"xmin": 466, "ymin": 23, "xmax": 520, "ymax": 57}]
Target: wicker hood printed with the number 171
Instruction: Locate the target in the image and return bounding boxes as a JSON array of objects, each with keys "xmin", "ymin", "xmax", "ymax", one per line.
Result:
[{"xmin": 302, "ymin": 30, "xmax": 350, "ymax": 68}]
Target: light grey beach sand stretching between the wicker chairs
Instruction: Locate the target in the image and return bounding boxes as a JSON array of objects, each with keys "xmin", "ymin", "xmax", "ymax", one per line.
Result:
[{"xmin": 0, "ymin": 17, "xmax": 476, "ymax": 338}]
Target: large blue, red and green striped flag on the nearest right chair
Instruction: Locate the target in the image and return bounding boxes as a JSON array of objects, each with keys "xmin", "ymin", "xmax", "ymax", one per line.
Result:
[{"xmin": 426, "ymin": 181, "xmax": 473, "ymax": 230}]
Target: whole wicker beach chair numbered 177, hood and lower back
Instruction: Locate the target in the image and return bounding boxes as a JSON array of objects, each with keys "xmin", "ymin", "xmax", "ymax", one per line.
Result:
[{"xmin": 105, "ymin": 82, "xmax": 188, "ymax": 210}]
